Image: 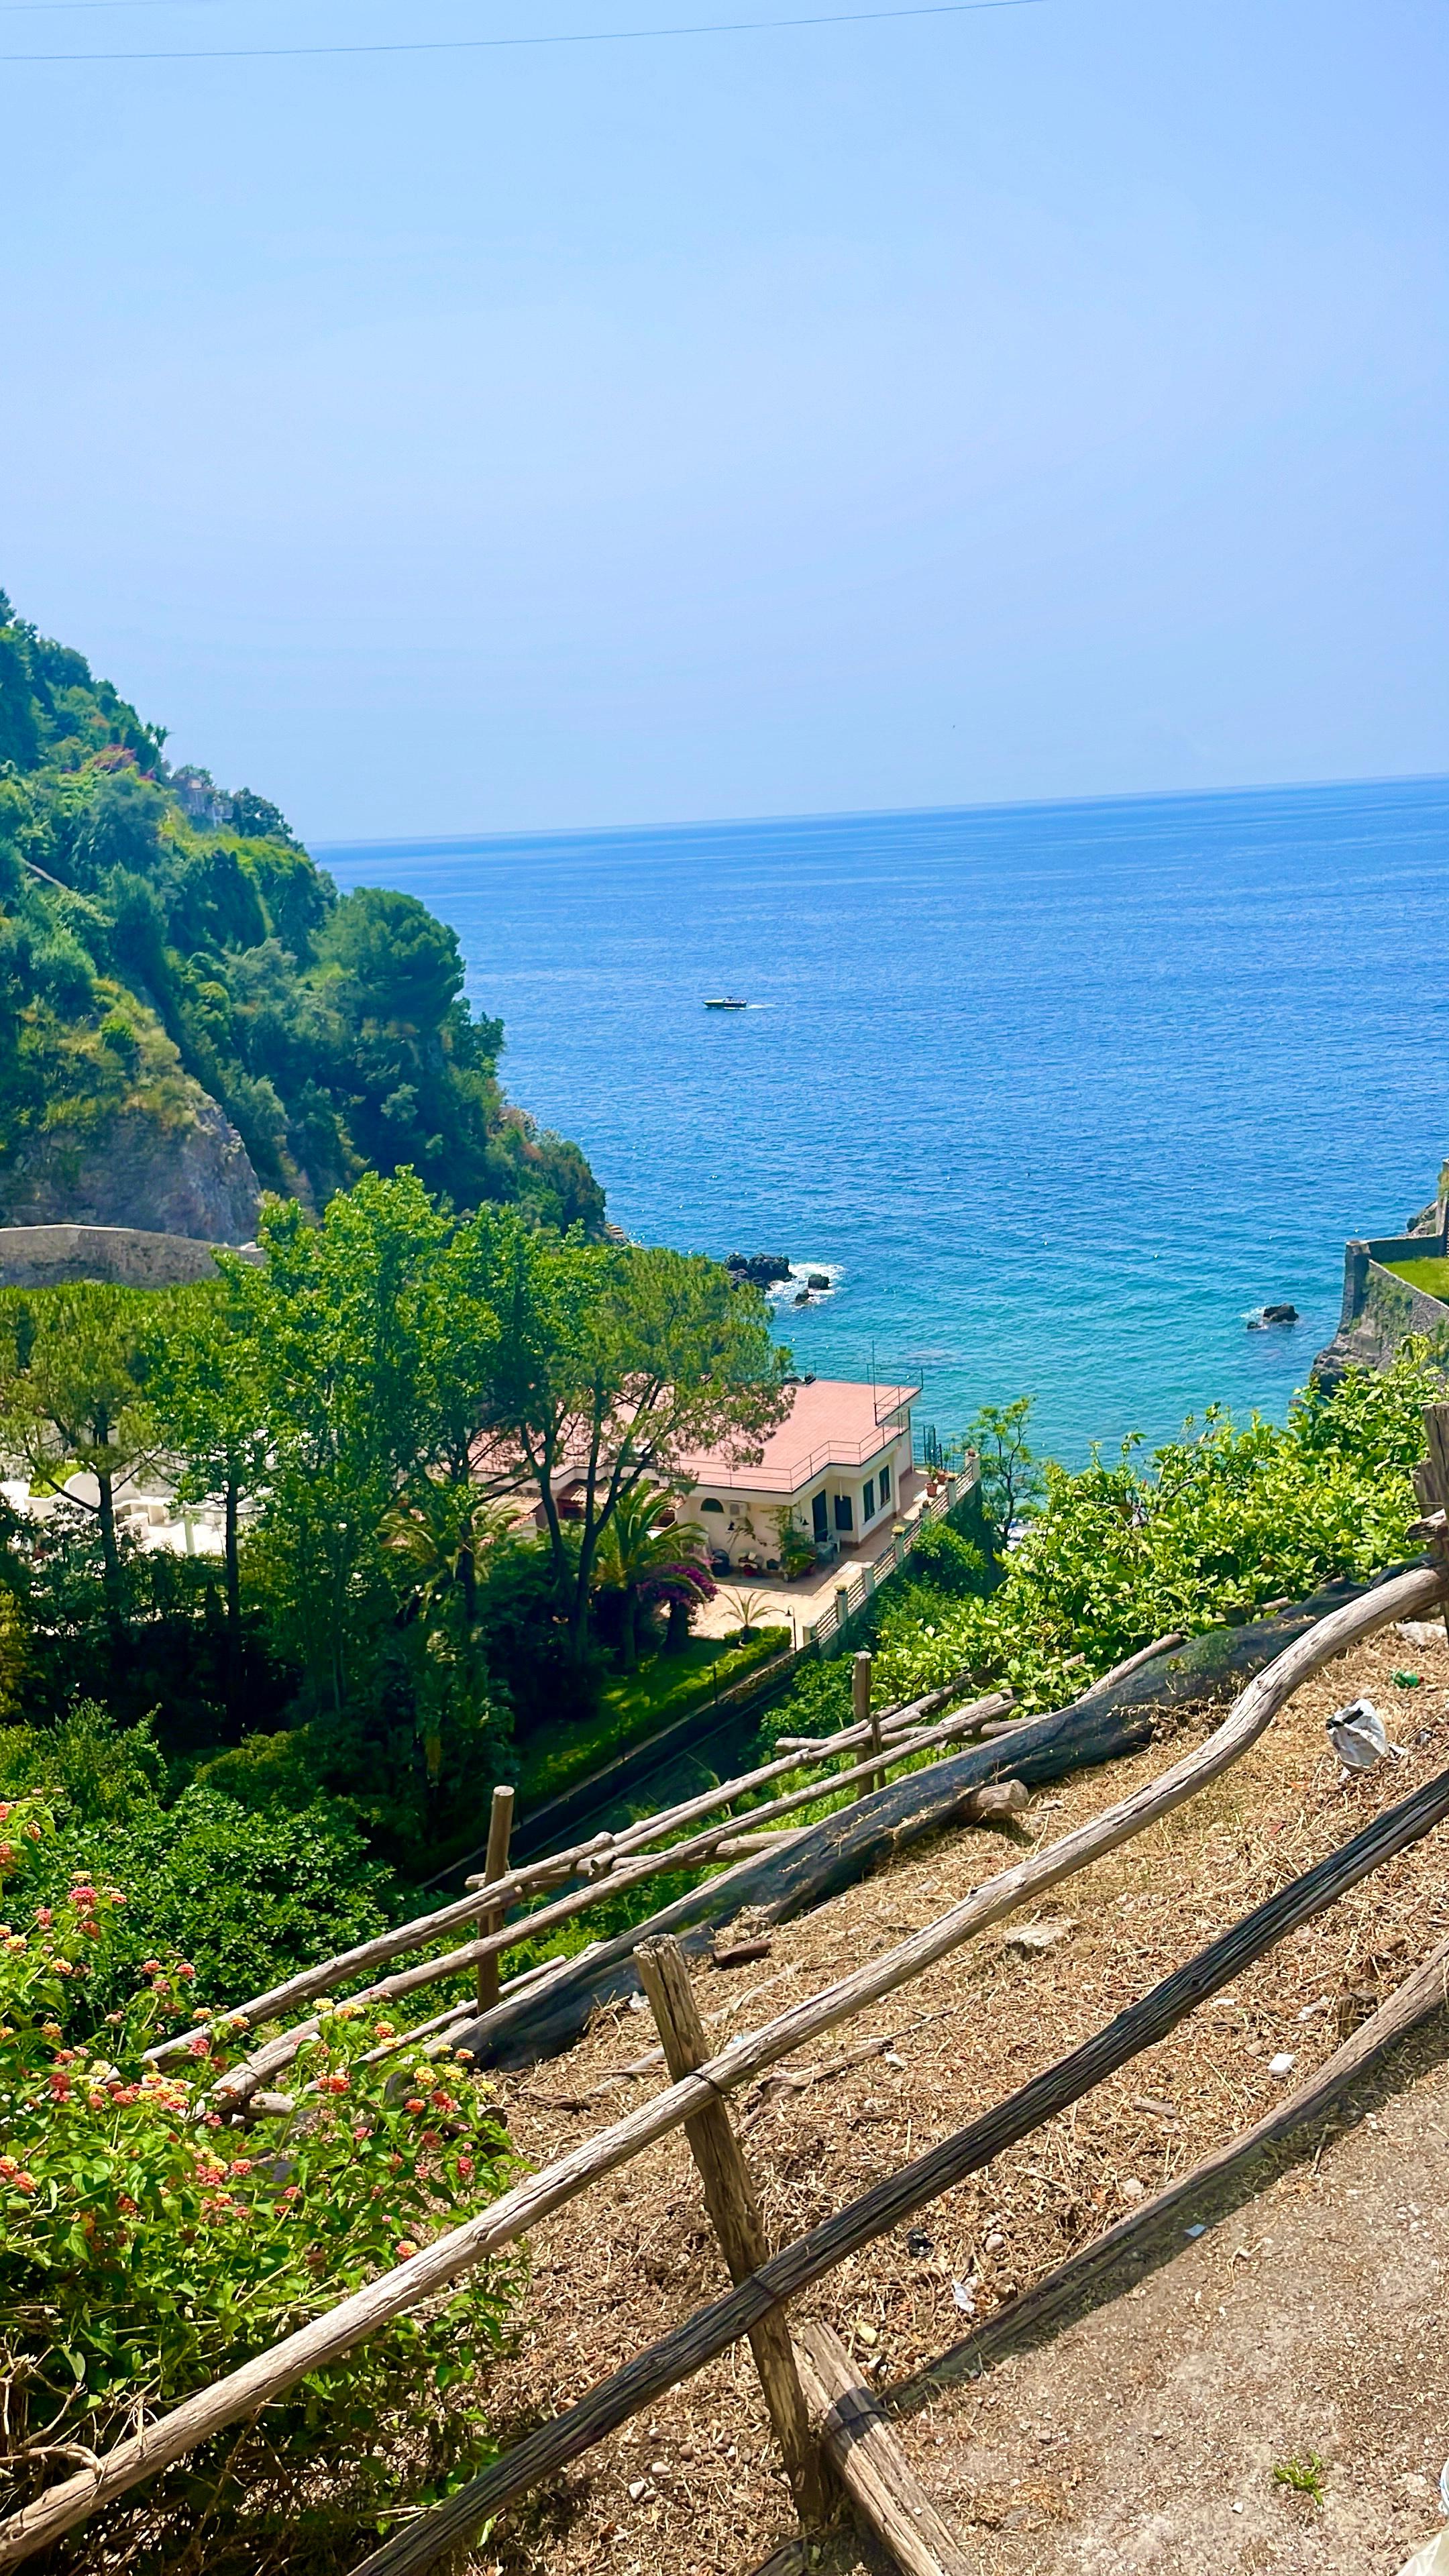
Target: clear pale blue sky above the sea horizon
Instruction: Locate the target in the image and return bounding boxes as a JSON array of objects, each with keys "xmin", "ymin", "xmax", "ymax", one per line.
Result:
[{"xmin": 0, "ymin": 0, "xmax": 1449, "ymax": 840}]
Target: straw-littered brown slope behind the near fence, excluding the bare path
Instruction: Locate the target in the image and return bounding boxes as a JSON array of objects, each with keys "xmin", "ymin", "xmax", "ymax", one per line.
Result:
[{"xmin": 456, "ymin": 1631, "xmax": 1449, "ymax": 2576}]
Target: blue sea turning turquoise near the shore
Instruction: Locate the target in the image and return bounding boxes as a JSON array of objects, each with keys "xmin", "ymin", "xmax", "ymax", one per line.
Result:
[{"xmin": 317, "ymin": 781, "xmax": 1449, "ymax": 1460}]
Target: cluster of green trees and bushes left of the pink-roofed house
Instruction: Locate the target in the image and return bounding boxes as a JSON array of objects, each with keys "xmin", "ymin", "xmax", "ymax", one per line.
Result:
[{"xmin": 0, "ymin": 1175, "xmax": 786, "ymax": 1999}]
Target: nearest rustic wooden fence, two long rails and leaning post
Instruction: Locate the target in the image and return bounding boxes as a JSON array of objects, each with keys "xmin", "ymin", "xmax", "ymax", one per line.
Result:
[{"xmin": 0, "ymin": 1564, "xmax": 1449, "ymax": 2576}]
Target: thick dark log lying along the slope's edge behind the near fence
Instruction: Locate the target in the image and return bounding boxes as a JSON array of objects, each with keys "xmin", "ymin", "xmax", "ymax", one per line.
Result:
[{"xmin": 464, "ymin": 1566, "xmax": 1413, "ymax": 2066}]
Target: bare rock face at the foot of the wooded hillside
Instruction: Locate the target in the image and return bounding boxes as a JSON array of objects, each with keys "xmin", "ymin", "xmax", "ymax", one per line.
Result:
[{"xmin": 0, "ymin": 1087, "xmax": 260, "ymax": 1244}]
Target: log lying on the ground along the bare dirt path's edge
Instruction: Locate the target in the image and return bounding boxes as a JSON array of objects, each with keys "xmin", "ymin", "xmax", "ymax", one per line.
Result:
[{"xmin": 884, "ymin": 1940, "xmax": 1449, "ymax": 2414}]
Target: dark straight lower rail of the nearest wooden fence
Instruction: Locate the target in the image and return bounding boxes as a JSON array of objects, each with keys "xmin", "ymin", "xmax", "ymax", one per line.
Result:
[{"xmin": 337, "ymin": 1772, "xmax": 1449, "ymax": 2576}]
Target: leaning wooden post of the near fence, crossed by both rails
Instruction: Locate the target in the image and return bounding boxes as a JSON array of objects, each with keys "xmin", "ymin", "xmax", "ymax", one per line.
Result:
[{"xmin": 634, "ymin": 1937, "xmax": 828, "ymax": 2524}]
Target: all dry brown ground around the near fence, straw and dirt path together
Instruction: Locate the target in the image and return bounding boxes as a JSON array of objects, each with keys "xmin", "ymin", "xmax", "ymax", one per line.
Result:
[{"xmin": 472, "ymin": 1633, "xmax": 1449, "ymax": 2576}]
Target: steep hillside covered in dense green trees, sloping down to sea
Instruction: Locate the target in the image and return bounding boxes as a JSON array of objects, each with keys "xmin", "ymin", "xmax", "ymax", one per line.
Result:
[{"xmin": 0, "ymin": 592, "xmax": 603, "ymax": 1239}]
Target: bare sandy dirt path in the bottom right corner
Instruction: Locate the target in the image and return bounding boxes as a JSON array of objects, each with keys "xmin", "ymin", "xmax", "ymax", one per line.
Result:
[{"xmin": 898, "ymin": 2035, "xmax": 1449, "ymax": 2576}]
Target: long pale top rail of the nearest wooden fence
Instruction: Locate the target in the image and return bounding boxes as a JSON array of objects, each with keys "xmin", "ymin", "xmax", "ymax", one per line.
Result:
[{"xmin": 0, "ymin": 1566, "xmax": 1444, "ymax": 2568}]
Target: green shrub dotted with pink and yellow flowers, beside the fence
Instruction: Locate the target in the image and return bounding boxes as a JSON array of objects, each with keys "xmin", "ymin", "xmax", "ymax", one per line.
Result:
[{"xmin": 0, "ymin": 1798, "xmax": 521, "ymax": 2576}]
